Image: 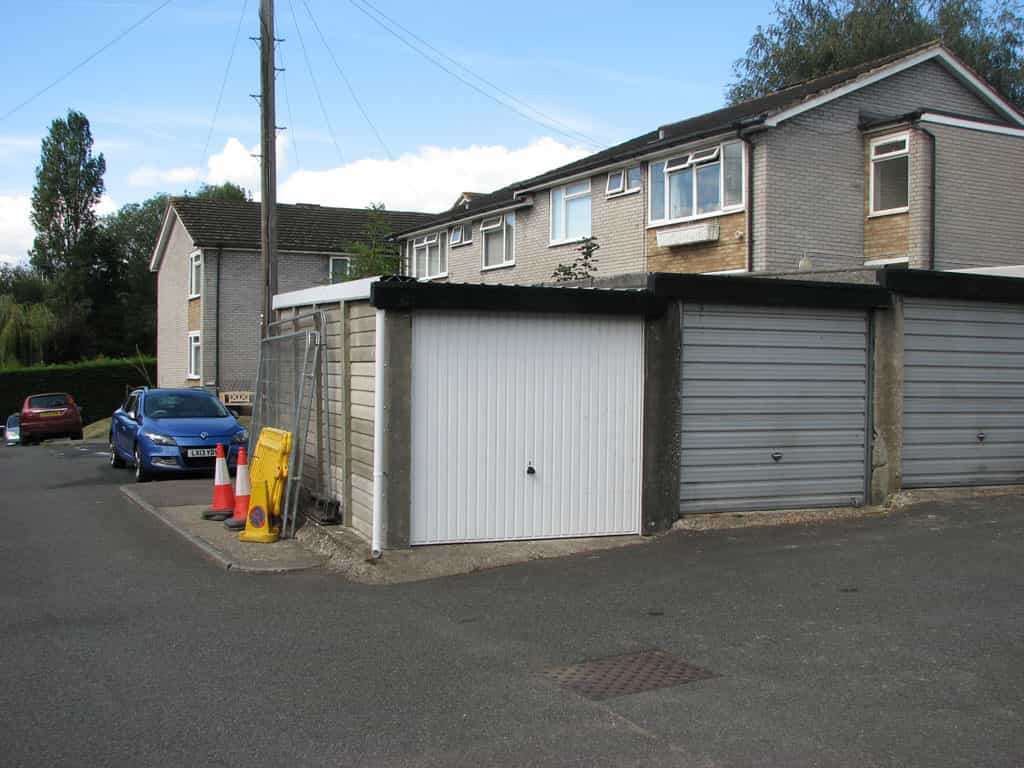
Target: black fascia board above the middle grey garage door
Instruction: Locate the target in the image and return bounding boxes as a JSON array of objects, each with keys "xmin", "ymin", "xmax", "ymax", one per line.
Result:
[{"xmin": 647, "ymin": 272, "xmax": 892, "ymax": 309}]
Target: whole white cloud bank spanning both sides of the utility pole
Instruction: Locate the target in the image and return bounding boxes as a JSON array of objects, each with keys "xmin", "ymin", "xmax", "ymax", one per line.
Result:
[{"xmin": 128, "ymin": 135, "xmax": 587, "ymax": 211}]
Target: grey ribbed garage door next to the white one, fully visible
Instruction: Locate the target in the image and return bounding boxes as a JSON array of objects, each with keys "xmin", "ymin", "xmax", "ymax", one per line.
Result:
[{"xmin": 680, "ymin": 304, "xmax": 868, "ymax": 512}]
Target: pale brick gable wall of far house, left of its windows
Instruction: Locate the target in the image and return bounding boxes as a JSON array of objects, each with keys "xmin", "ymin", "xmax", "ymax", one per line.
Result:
[{"xmin": 157, "ymin": 217, "xmax": 195, "ymax": 387}]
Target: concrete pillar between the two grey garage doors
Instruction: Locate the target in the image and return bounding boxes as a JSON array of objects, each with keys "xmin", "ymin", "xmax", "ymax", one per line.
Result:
[{"xmin": 869, "ymin": 296, "xmax": 903, "ymax": 504}]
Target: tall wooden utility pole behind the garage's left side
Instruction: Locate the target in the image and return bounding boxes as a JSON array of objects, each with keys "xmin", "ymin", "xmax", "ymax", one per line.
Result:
[{"xmin": 259, "ymin": 0, "xmax": 278, "ymax": 337}]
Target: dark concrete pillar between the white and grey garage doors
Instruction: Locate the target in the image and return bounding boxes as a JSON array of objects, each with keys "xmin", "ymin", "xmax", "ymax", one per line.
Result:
[{"xmin": 640, "ymin": 301, "xmax": 683, "ymax": 536}]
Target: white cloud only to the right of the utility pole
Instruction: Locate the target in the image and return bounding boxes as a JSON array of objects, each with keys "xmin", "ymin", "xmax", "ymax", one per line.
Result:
[{"xmin": 279, "ymin": 137, "xmax": 587, "ymax": 211}]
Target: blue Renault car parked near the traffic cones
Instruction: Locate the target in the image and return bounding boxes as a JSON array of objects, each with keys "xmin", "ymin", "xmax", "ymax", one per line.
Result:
[{"xmin": 110, "ymin": 389, "xmax": 249, "ymax": 482}]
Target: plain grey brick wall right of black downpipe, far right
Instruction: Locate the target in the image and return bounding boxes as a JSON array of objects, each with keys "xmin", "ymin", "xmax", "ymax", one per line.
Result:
[{"xmin": 928, "ymin": 125, "xmax": 1024, "ymax": 270}]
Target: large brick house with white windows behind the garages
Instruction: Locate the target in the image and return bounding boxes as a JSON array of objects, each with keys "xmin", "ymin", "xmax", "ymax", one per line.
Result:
[{"xmin": 398, "ymin": 43, "xmax": 1024, "ymax": 284}]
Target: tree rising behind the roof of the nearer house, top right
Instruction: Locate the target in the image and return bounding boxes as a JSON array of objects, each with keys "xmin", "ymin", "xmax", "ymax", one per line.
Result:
[{"xmin": 727, "ymin": 0, "xmax": 1024, "ymax": 109}]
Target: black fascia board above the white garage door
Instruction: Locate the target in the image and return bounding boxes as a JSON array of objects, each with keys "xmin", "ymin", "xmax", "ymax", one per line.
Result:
[{"xmin": 370, "ymin": 279, "xmax": 665, "ymax": 316}]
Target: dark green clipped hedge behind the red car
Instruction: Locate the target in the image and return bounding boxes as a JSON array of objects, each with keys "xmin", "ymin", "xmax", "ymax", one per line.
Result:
[{"xmin": 0, "ymin": 357, "xmax": 157, "ymax": 424}]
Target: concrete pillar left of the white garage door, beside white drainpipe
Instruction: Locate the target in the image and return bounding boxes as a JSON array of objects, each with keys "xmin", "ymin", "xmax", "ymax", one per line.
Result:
[{"xmin": 374, "ymin": 309, "xmax": 413, "ymax": 549}]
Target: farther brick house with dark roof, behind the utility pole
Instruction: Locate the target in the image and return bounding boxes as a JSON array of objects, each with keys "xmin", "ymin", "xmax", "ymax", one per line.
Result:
[{"xmin": 150, "ymin": 198, "xmax": 433, "ymax": 392}]
